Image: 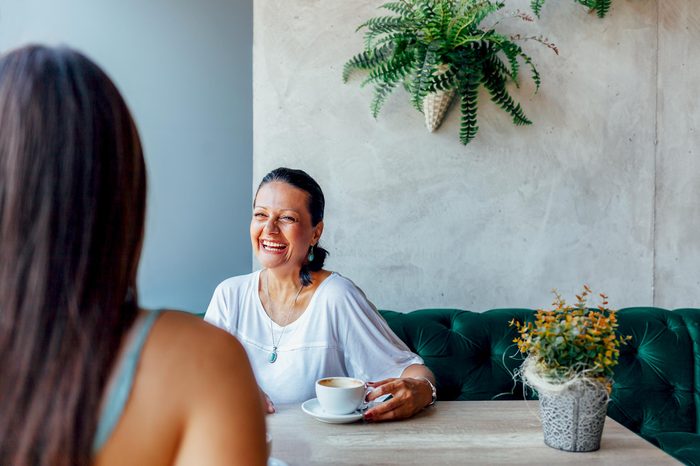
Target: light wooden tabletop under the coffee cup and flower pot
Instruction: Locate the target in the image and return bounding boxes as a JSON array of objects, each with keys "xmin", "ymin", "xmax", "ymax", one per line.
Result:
[{"xmin": 267, "ymin": 401, "xmax": 680, "ymax": 466}]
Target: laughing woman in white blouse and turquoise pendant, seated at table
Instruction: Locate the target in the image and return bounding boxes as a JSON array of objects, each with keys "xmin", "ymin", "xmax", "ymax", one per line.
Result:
[{"xmin": 205, "ymin": 168, "xmax": 435, "ymax": 421}]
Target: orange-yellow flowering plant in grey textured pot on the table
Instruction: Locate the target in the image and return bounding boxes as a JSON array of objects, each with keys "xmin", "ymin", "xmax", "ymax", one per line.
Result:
[{"xmin": 510, "ymin": 285, "xmax": 630, "ymax": 451}]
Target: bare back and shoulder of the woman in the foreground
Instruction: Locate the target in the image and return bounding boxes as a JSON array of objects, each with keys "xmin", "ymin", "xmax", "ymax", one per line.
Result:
[{"xmin": 95, "ymin": 312, "xmax": 265, "ymax": 466}]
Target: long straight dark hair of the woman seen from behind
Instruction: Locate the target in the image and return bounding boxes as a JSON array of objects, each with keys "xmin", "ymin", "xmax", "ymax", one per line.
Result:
[{"xmin": 0, "ymin": 46, "xmax": 146, "ymax": 466}]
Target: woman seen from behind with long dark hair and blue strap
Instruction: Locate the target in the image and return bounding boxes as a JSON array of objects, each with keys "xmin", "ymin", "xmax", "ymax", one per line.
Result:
[{"xmin": 0, "ymin": 46, "xmax": 265, "ymax": 466}]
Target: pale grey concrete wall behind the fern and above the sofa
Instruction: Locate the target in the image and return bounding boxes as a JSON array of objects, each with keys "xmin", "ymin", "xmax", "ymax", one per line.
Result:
[{"xmin": 253, "ymin": 0, "xmax": 700, "ymax": 310}]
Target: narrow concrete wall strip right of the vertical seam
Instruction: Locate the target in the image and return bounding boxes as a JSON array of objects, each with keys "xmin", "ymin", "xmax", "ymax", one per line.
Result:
[{"xmin": 654, "ymin": 0, "xmax": 700, "ymax": 306}]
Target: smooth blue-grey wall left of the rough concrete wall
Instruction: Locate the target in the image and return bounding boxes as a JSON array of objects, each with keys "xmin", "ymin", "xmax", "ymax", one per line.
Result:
[{"xmin": 0, "ymin": 0, "xmax": 252, "ymax": 311}]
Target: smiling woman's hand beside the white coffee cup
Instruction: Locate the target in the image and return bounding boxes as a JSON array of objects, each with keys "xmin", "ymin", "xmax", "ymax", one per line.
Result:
[{"xmin": 364, "ymin": 377, "xmax": 433, "ymax": 421}]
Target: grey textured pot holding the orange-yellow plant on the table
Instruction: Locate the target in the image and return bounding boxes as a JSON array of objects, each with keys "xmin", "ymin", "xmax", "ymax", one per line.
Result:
[{"xmin": 539, "ymin": 381, "xmax": 608, "ymax": 451}]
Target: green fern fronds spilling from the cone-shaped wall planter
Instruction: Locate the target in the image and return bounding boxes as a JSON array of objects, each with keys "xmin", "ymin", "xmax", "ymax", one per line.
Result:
[{"xmin": 343, "ymin": 0, "xmax": 557, "ymax": 144}]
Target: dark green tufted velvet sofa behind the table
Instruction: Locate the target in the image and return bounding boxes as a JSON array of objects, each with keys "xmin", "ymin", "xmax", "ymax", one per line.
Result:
[{"xmin": 380, "ymin": 307, "xmax": 700, "ymax": 465}]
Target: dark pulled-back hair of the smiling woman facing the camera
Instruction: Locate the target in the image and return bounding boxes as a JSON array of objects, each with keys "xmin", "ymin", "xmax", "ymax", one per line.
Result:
[{"xmin": 253, "ymin": 167, "xmax": 328, "ymax": 286}]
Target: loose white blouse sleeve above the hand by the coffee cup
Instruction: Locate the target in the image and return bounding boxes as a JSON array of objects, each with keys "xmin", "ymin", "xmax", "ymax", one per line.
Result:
[{"xmin": 336, "ymin": 280, "xmax": 423, "ymax": 382}]
